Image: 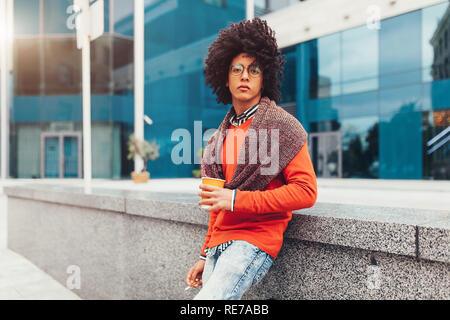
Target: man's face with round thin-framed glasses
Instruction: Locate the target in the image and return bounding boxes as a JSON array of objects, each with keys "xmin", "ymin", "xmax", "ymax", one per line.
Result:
[{"xmin": 226, "ymin": 53, "xmax": 263, "ymax": 103}]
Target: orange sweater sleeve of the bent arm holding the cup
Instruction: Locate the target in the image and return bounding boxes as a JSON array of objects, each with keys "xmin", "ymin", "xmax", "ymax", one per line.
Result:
[{"xmin": 234, "ymin": 142, "xmax": 317, "ymax": 213}]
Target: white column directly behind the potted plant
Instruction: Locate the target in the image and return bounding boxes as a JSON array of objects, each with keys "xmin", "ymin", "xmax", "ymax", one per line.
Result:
[{"xmin": 134, "ymin": 0, "xmax": 145, "ymax": 172}]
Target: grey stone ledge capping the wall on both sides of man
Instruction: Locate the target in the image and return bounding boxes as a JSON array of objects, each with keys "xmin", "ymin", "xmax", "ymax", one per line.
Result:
[{"xmin": 4, "ymin": 184, "xmax": 450, "ymax": 263}]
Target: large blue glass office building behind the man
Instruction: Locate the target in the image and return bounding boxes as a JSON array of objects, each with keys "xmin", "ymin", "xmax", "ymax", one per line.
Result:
[{"xmin": 4, "ymin": 0, "xmax": 450, "ymax": 180}]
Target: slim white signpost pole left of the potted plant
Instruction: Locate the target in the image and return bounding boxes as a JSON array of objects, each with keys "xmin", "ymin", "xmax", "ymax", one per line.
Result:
[{"xmin": 80, "ymin": 1, "xmax": 92, "ymax": 188}]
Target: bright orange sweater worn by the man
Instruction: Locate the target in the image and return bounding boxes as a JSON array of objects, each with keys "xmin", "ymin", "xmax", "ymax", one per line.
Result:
[{"xmin": 201, "ymin": 117, "xmax": 317, "ymax": 258}]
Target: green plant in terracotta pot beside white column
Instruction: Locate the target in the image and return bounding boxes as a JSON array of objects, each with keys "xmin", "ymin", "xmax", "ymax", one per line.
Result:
[{"xmin": 128, "ymin": 134, "xmax": 160, "ymax": 183}]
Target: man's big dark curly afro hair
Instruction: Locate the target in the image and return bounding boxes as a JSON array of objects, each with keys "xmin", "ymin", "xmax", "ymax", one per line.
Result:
[{"xmin": 204, "ymin": 18, "xmax": 286, "ymax": 105}]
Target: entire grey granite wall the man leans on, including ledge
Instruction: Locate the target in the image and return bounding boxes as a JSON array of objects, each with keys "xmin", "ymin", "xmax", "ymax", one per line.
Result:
[{"xmin": 5, "ymin": 186, "xmax": 450, "ymax": 299}]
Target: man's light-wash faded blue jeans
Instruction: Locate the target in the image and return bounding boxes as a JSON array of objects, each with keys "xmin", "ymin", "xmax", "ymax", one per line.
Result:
[{"xmin": 194, "ymin": 240, "xmax": 274, "ymax": 300}]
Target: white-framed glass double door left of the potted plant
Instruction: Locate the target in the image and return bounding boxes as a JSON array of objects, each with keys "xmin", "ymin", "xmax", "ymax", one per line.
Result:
[{"xmin": 41, "ymin": 132, "xmax": 81, "ymax": 178}]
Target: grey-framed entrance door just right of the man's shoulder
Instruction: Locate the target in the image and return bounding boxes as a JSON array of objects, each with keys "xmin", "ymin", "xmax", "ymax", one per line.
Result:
[{"xmin": 308, "ymin": 131, "xmax": 342, "ymax": 178}]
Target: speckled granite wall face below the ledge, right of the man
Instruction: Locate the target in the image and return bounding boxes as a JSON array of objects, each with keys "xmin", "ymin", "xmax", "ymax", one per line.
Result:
[{"xmin": 244, "ymin": 239, "xmax": 450, "ymax": 300}]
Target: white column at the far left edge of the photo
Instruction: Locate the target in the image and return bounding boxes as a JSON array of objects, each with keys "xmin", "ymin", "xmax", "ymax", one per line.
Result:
[{"xmin": 0, "ymin": 1, "xmax": 9, "ymax": 179}]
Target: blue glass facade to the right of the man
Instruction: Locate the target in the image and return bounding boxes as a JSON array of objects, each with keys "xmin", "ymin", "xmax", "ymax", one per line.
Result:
[{"xmin": 283, "ymin": 2, "xmax": 450, "ymax": 179}]
